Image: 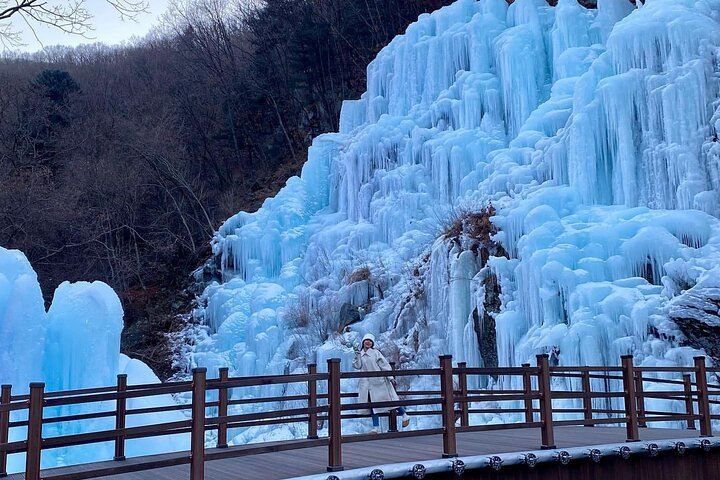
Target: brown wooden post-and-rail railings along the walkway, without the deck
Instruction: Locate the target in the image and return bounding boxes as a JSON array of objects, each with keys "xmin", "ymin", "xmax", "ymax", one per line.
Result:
[{"xmin": 0, "ymin": 355, "xmax": 720, "ymax": 480}]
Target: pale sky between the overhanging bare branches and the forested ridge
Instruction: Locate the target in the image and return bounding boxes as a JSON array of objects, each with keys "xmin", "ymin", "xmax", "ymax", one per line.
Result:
[{"xmin": 7, "ymin": 0, "xmax": 170, "ymax": 52}]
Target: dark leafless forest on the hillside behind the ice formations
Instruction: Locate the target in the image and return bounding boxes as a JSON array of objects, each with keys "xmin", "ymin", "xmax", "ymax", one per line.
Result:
[{"xmin": 0, "ymin": 0, "xmax": 450, "ymax": 375}]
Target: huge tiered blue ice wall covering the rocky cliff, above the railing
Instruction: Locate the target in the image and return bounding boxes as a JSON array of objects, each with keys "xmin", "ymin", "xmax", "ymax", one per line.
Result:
[{"xmin": 191, "ymin": 0, "xmax": 720, "ymax": 438}]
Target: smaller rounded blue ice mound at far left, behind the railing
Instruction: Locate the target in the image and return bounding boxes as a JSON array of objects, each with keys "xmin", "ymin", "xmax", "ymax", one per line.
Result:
[{"xmin": 0, "ymin": 247, "xmax": 189, "ymax": 473}]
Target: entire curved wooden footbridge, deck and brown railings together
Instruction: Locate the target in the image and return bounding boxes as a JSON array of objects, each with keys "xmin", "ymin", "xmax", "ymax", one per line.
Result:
[{"xmin": 0, "ymin": 355, "xmax": 720, "ymax": 480}]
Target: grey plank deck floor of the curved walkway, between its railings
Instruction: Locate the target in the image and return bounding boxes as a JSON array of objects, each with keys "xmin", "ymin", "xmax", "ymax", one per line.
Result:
[{"xmin": 7, "ymin": 427, "xmax": 698, "ymax": 480}]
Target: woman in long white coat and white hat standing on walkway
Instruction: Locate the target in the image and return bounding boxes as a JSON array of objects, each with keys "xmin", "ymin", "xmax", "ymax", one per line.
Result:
[{"xmin": 353, "ymin": 333, "xmax": 410, "ymax": 433}]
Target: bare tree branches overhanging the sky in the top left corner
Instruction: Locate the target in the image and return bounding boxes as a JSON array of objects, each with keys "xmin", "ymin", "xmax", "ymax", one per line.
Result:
[{"xmin": 0, "ymin": 0, "xmax": 149, "ymax": 47}]
